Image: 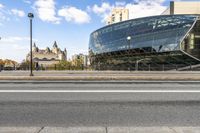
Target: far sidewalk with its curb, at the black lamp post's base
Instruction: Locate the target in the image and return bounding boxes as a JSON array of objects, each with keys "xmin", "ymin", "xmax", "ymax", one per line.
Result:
[{"xmin": 0, "ymin": 71, "xmax": 200, "ymax": 81}]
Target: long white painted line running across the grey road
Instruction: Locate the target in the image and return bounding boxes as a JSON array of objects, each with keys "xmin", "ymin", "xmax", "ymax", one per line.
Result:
[{"xmin": 0, "ymin": 90, "xmax": 200, "ymax": 93}]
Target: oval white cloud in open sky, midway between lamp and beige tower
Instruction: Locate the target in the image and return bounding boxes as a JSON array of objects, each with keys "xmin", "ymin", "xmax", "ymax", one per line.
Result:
[{"xmin": 58, "ymin": 7, "xmax": 91, "ymax": 24}]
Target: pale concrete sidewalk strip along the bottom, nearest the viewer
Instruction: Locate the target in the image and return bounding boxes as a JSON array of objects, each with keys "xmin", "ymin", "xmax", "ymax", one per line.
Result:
[{"xmin": 0, "ymin": 127, "xmax": 200, "ymax": 133}]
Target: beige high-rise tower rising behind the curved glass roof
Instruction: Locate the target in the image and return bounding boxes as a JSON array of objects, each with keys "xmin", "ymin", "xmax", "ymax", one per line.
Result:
[{"xmin": 106, "ymin": 7, "xmax": 129, "ymax": 25}]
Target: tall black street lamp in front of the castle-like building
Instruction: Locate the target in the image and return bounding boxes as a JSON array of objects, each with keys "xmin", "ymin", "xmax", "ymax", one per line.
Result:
[{"xmin": 28, "ymin": 13, "xmax": 34, "ymax": 76}]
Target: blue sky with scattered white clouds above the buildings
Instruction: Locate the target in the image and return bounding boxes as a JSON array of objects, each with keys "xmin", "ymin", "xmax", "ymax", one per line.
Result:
[{"xmin": 0, "ymin": 0, "xmax": 198, "ymax": 62}]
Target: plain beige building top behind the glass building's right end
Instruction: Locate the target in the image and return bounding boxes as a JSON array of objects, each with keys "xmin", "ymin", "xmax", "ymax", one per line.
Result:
[{"xmin": 170, "ymin": 1, "xmax": 200, "ymax": 15}]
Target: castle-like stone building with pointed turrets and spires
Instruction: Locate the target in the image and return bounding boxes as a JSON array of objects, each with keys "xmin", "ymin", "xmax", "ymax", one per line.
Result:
[{"xmin": 27, "ymin": 41, "xmax": 67, "ymax": 66}]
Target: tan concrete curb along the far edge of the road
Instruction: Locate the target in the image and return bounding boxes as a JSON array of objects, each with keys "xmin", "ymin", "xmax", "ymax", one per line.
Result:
[{"xmin": 0, "ymin": 75, "xmax": 200, "ymax": 81}]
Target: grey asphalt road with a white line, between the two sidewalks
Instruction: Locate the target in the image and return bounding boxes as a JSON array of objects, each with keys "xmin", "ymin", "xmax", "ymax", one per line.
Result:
[{"xmin": 0, "ymin": 81, "xmax": 200, "ymax": 127}]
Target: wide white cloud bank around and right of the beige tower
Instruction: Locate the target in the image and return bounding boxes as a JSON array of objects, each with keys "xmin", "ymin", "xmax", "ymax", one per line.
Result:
[{"xmin": 91, "ymin": 0, "xmax": 167, "ymax": 22}]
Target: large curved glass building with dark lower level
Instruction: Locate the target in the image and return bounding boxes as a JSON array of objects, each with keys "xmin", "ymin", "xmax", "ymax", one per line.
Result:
[{"xmin": 89, "ymin": 15, "xmax": 200, "ymax": 70}]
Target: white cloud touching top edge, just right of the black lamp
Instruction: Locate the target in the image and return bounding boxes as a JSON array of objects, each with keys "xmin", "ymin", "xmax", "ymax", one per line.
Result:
[{"xmin": 34, "ymin": 0, "xmax": 60, "ymax": 24}]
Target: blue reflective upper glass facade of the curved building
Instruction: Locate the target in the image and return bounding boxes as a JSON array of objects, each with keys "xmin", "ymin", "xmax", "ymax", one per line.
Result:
[{"xmin": 89, "ymin": 15, "xmax": 197, "ymax": 54}]
